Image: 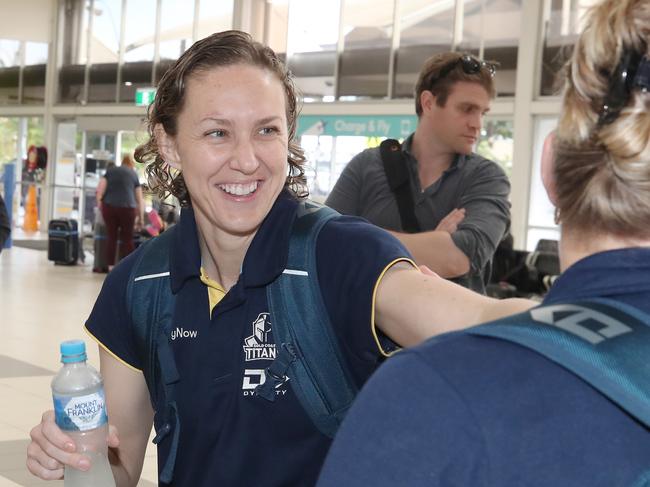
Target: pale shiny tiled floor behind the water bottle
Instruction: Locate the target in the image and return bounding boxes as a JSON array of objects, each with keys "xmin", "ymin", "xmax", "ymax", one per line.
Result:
[{"xmin": 0, "ymin": 247, "xmax": 157, "ymax": 487}]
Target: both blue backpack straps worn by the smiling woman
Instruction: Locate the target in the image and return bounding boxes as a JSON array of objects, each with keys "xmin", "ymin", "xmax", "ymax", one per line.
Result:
[{"xmin": 127, "ymin": 201, "xmax": 357, "ymax": 482}]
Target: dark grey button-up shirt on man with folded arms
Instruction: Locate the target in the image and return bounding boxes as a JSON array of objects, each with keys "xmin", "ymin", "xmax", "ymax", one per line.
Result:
[{"xmin": 325, "ymin": 135, "xmax": 510, "ymax": 293}]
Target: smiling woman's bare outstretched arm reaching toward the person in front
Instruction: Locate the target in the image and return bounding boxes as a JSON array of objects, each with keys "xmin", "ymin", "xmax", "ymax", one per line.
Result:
[{"xmin": 375, "ymin": 264, "xmax": 538, "ymax": 347}]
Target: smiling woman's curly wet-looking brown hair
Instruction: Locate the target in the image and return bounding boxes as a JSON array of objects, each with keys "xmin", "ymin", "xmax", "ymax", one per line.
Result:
[{"xmin": 135, "ymin": 30, "xmax": 309, "ymax": 206}]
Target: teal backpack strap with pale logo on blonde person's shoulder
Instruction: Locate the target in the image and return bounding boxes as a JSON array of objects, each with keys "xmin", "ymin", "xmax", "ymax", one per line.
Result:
[{"xmin": 464, "ymin": 299, "xmax": 650, "ymax": 426}]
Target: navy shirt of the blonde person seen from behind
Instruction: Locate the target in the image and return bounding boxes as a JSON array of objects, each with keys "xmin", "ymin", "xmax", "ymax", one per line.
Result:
[{"xmin": 318, "ymin": 248, "xmax": 650, "ymax": 487}]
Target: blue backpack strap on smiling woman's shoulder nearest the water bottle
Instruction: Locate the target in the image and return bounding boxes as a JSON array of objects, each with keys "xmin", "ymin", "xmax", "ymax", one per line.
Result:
[{"xmin": 127, "ymin": 226, "xmax": 180, "ymax": 483}]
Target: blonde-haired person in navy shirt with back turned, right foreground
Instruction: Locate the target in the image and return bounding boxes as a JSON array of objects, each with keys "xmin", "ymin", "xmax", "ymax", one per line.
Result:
[{"xmin": 318, "ymin": 0, "xmax": 650, "ymax": 487}]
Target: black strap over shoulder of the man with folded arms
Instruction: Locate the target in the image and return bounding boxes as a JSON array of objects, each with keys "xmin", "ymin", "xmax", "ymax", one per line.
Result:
[{"xmin": 379, "ymin": 139, "xmax": 420, "ymax": 233}]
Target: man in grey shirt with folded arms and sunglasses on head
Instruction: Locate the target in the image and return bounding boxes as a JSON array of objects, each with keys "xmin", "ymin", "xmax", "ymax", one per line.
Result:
[{"xmin": 326, "ymin": 53, "xmax": 510, "ymax": 293}]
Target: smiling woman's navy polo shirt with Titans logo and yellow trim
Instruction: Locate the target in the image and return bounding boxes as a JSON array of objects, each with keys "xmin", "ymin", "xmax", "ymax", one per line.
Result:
[{"xmin": 86, "ymin": 193, "xmax": 409, "ymax": 487}]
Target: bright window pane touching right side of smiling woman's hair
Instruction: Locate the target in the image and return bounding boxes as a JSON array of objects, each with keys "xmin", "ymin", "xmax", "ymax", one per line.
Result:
[{"xmin": 287, "ymin": 0, "xmax": 340, "ymax": 102}]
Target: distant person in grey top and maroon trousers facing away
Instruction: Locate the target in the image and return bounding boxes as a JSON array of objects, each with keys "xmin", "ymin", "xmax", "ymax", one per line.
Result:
[{"xmin": 96, "ymin": 154, "xmax": 144, "ymax": 271}]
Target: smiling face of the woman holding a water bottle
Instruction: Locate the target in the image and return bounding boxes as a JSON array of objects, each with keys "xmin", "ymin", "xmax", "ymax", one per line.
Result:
[{"xmin": 161, "ymin": 64, "xmax": 288, "ymax": 240}]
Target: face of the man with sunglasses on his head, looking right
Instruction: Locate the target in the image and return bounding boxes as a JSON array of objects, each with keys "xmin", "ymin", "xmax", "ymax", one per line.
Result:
[{"xmin": 425, "ymin": 81, "xmax": 491, "ymax": 154}]
